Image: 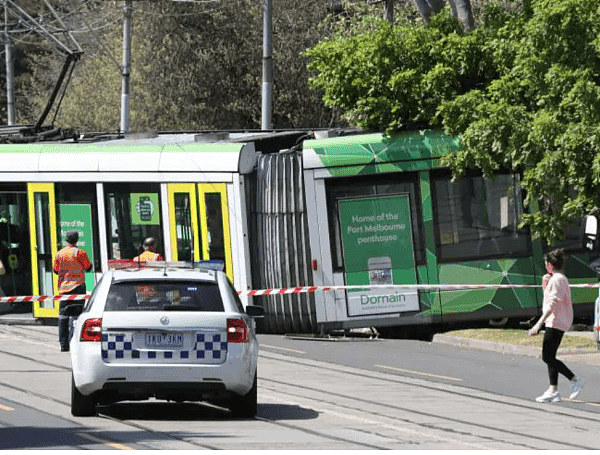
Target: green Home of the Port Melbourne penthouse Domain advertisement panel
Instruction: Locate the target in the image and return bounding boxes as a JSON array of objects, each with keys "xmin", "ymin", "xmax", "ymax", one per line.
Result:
[{"xmin": 339, "ymin": 194, "xmax": 419, "ymax": 316}]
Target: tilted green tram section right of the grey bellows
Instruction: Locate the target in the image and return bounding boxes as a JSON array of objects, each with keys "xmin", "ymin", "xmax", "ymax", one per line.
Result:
[{"xmin": 303, "ymin": 131, "xmax": 596, "ymax": 338}]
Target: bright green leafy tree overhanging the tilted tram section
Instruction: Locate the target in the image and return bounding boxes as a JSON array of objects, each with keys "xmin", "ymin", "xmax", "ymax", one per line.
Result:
[{"xmin": 306, "ymin": 0, "xmax": 600, "ymax": 241}]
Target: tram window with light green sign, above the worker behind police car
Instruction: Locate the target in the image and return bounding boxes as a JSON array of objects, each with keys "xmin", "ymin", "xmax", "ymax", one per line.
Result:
[{"xmin": 104, "ymin": 183, "xmax": 164, "ymax": 259}]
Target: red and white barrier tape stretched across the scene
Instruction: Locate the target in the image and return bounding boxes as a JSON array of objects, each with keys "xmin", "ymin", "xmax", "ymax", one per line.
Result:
[{"xmin": 0, "ymin": 283, "xmax": 600, "ymax": 303}]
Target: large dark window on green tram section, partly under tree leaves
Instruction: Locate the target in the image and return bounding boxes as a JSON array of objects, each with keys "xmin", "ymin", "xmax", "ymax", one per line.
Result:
[{"xmin": 432, "ymin": 173, "xmax": 531, "ymax": 261}]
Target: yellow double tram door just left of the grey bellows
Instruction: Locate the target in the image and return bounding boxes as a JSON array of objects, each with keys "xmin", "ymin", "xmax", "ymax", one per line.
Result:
[{"xmin": 168, "ymin": 183, "xmax": 233, "ymax": 280}]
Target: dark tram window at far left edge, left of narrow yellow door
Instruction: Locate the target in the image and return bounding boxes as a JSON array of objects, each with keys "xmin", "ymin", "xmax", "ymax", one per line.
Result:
[{"xmin": 0, "ymin": 184, "xmax": 32, "ymax": 295}]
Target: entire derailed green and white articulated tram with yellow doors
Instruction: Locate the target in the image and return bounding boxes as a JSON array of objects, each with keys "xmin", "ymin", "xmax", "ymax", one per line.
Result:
[{"xmin": 0, "ymin": 130, "xmax": 596, "ymax": 337}]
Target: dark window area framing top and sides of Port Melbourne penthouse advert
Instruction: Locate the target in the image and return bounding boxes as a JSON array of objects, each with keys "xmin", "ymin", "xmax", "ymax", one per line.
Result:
[{"xmin": 326, "ymin": 172, "xmax": 425, "ymax": 271}]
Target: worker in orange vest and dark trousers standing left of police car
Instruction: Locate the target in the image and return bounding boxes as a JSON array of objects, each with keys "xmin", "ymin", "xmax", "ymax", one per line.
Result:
[{"xmin": 52, "ymin": 231, "xmax": 92, "ymax": 352}]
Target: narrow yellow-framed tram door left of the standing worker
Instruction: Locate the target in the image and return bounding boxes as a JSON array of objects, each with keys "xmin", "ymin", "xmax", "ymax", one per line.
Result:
[{"xmin": 27, "ymin": 183, "xmax": 59, "ymax": 318}]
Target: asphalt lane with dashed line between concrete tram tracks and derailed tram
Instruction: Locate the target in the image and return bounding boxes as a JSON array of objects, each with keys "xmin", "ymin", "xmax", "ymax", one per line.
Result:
[{"xmin": 261, "ymin": 336, "xmax": 600, "ymax": 413}]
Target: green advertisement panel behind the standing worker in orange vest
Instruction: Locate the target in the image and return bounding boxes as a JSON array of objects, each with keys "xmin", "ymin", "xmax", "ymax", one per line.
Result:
[{"xmin": 59, "ymin": 204, "xmax": 96, "ymax": 291}]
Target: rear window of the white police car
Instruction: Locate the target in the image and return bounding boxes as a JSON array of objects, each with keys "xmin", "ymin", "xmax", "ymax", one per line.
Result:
[{"xmin": 104, "ymin": 281, "xmax": 225, "ymax": 312}]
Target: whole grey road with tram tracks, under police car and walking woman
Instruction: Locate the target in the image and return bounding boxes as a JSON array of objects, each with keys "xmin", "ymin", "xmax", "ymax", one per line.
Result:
[{"xmin": 0, "ymin": 326, "xmax": 600, "ymax": 450}]
